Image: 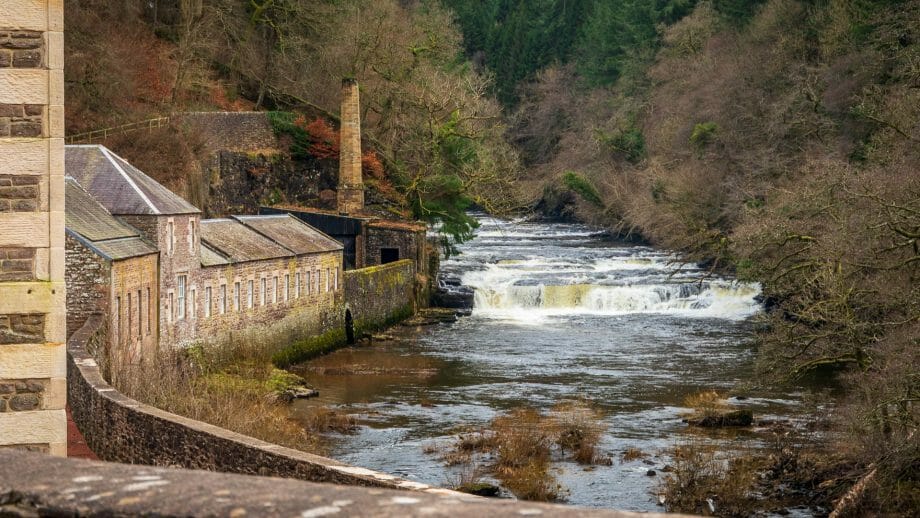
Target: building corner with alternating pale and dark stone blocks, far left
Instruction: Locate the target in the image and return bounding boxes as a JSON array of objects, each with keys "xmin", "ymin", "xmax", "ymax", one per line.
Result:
[{"xmin": 0, "ymin": 0, "xmax": 66, "ymax": 455}]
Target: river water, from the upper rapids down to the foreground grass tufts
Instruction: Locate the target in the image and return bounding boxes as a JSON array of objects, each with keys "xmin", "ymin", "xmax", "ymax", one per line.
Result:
[{"xmin": 295, "ymin": 218, "xmax": 798, "ymax": 511}]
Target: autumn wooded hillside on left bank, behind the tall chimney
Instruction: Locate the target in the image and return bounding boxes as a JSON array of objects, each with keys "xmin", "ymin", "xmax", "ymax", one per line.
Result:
[{"xmin": 65, "ymin": 0, "xmax": 518, "ymax": 248}]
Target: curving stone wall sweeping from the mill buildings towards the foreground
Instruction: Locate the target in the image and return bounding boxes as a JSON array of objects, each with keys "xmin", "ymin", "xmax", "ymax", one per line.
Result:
[{"xmin": 67, "ymin": 316, "xmax": 443, "ymax": 496}]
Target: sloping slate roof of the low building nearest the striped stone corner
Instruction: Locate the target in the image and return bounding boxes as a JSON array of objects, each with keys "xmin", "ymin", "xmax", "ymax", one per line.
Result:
[{"xmin": 64, "ymin": 177, "xmax": 157, "ymax": 260}]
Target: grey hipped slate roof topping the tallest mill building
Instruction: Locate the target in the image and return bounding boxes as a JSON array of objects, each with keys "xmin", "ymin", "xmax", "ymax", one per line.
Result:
[{"xmin": 64, "ymin": 145, "xmax": 201, "ymax": 215}]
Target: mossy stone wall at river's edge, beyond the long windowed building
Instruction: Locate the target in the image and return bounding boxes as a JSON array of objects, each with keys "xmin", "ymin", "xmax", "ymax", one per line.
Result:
[{"xmin": 345, "ymin": 260, "xmax": 416, "ymax": 329}]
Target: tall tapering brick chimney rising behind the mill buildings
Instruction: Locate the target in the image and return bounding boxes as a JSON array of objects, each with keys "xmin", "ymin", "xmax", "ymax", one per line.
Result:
[{"xmin": 336, "ymin": 79, "xmax": 364, "ymax": 214}]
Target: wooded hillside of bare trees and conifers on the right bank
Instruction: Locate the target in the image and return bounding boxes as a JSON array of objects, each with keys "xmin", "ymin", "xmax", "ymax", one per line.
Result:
[{"xmin": 446, "ymin": 0, "xmax": 920, "ymax": 515}]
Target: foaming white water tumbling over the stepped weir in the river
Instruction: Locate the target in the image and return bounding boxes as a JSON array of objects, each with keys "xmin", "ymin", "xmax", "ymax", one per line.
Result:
[{"xmin": 459, "ymin": 219, "xmax": 760, "ymax": 323}]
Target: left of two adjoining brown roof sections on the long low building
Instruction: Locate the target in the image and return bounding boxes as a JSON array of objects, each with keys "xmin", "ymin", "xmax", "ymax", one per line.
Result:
[{"xmin": 201, "ymin": 219, "xmax": 294, "ymax": 263}]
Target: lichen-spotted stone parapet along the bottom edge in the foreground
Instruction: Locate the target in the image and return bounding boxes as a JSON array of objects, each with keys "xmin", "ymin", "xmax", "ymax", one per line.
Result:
[{"xmin": 0, "ymin": 451, "xmax": 680, "ymax": 518}]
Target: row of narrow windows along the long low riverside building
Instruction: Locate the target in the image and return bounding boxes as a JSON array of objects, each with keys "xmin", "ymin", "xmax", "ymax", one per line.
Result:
[{"xmin": 166, "ymin": 268, "xmax": 339, "ymax": 323}]
